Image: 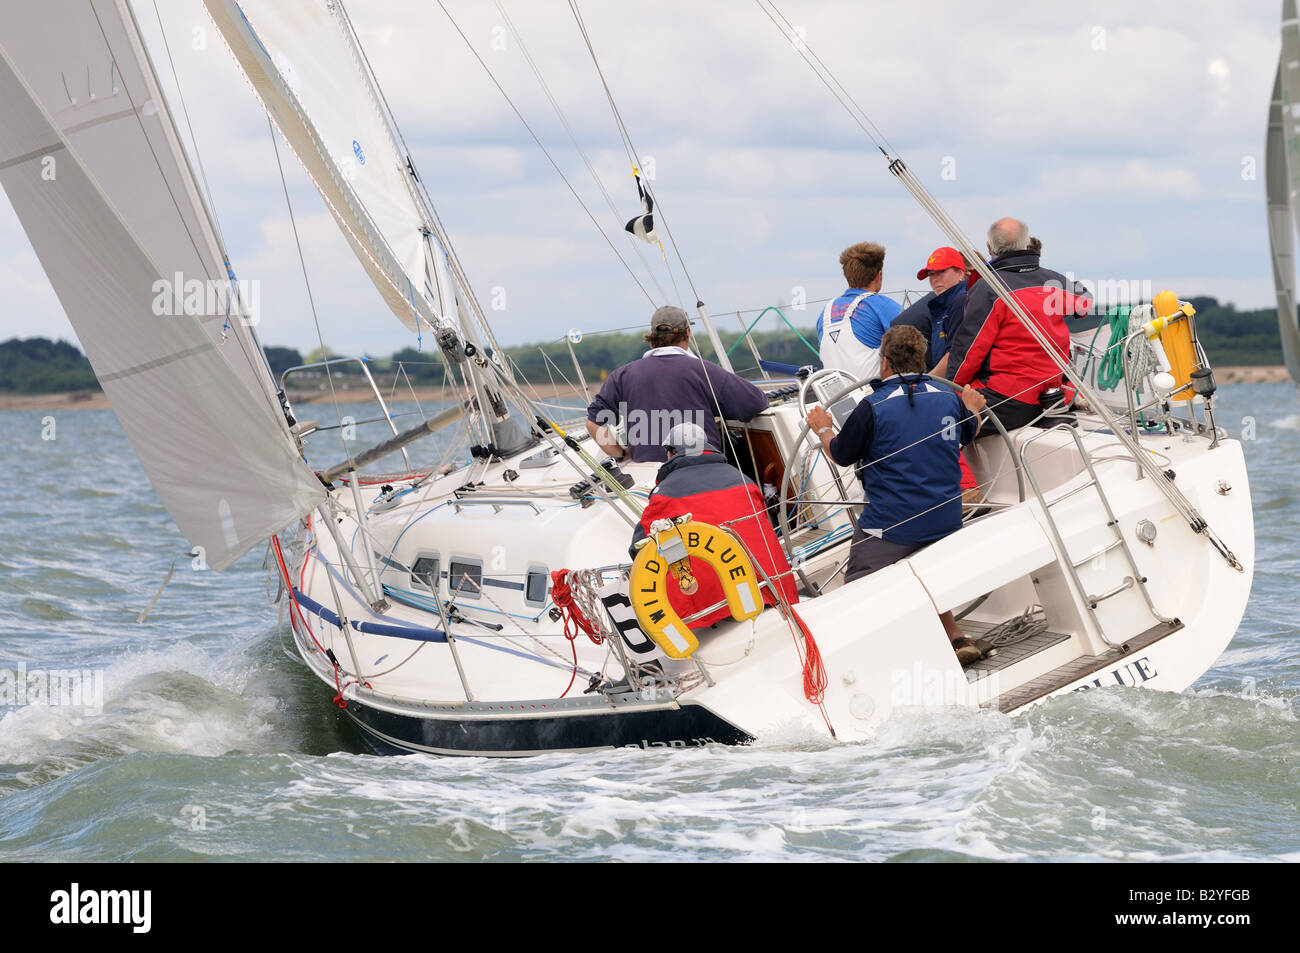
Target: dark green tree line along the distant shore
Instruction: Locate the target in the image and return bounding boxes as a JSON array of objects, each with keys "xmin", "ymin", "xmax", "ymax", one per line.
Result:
[{"xmin": 0, "ymin": 296, "xmax": 1282, "ymax": 394}]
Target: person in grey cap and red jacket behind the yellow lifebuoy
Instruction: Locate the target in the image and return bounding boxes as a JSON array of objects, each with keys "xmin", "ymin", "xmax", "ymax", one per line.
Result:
[{"xmin": 632, "ymin": 421, "xmax": 800, "ymax": 629}]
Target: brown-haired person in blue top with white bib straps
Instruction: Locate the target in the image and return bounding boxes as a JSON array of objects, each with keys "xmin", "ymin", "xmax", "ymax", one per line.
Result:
[{"xmin": 816, "ymin": 242, "xmax": 901, "ymax": 381}]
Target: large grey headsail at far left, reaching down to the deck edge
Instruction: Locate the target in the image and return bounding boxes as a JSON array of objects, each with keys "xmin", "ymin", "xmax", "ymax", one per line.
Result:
[{"xmin": 0, "ymin": 0, "xmax": 324, "ymax": 569}]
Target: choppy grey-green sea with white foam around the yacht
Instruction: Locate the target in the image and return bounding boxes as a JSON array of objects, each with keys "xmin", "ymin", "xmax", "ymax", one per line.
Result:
[{"xmin": 0, "ymin": 385, "xmax": 1300, "ymax": 862}]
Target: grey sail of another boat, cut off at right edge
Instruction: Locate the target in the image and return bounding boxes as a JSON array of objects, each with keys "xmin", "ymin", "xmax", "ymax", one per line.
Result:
[{"xmin": 1264, "ymin": 0, "xmax": 1300, "ymax": 384}]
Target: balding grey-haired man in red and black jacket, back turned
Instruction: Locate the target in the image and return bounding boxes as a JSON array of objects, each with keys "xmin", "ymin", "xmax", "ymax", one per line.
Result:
[{"xmin": 945, "ymin": 218, "xmax": 1092, "ymax": 430}]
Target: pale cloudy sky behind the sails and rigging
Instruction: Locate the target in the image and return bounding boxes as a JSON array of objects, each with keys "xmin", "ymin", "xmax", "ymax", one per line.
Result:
[{"xmin": 0, "ymin": 0, "xmax": 1281, "ymax": 355}]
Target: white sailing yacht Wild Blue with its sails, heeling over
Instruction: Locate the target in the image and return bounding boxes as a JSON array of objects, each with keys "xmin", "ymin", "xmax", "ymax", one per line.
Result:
[{"xmin": 0, "ymin": 0, "xmax": 1255, "ymax": 757}]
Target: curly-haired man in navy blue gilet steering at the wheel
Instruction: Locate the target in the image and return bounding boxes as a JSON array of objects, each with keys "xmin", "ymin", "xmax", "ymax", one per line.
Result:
[{"xmin": 807, "ymin": 325, "xmax": 984, "ymax": 664}]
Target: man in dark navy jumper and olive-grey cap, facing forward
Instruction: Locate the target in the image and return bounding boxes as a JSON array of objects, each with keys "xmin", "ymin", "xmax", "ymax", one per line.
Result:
[{"xmin": 586, "ymin": 306, "xmax": 767, "ymax": 463}]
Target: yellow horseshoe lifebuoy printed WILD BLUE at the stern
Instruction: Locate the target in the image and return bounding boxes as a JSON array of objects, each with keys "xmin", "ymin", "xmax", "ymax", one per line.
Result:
[{"xmin": 628, "ymin": 520, "xmax": 763, "ymax": 658}]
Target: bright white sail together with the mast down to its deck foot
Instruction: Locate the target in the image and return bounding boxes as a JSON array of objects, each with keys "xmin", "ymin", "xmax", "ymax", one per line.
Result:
[{"xmin": 203, "ymin": 0, "xmax": 530, "ymax": 452}]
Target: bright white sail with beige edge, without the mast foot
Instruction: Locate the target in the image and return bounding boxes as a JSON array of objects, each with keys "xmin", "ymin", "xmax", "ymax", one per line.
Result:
[{"xmin": 204, "ymin": 0, "xmax": 456, "ymax": 330}]
